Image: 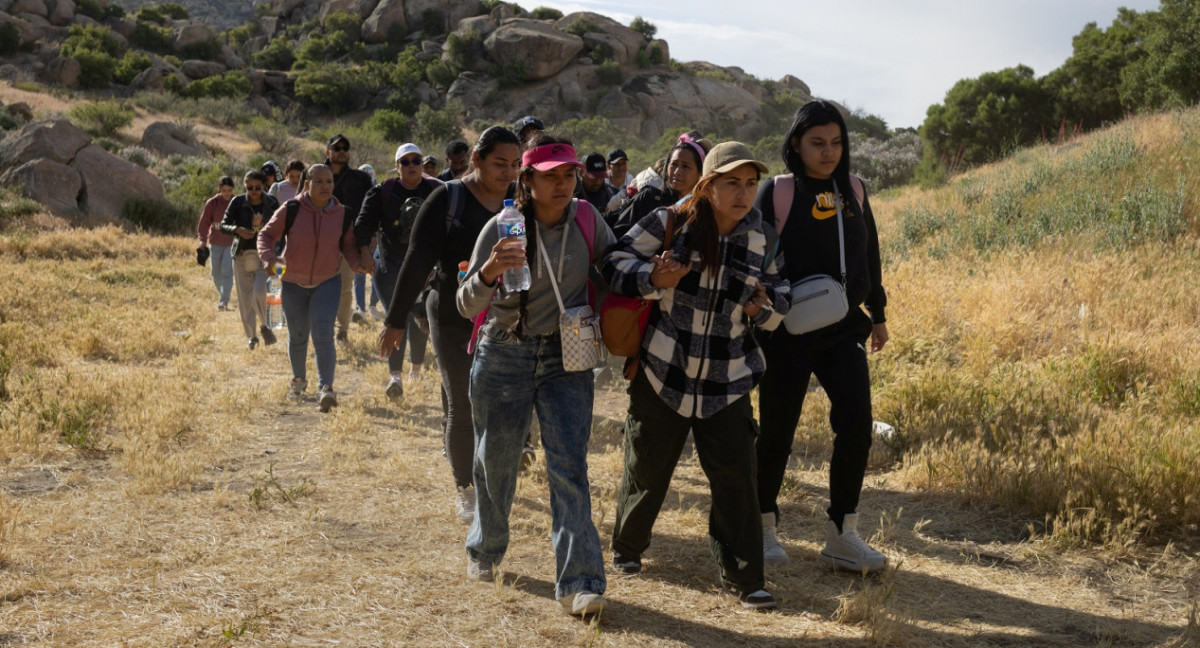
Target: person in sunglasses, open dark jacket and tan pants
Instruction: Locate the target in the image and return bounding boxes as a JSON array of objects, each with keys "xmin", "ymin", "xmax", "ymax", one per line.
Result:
[{"xmin": 221, "ymin": 170, "xmax": 280, "ymax": 349}]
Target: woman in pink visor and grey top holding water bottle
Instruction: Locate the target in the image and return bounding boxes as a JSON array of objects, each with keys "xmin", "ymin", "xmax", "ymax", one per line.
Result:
[{"xmin": 458, "ymin": 133, "xmax": 614, "ymax": 616}]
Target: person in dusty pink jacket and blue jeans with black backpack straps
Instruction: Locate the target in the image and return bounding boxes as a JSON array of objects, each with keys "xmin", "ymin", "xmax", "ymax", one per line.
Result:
[{"xmin": 258, "ymin": 164, "xmax": 360, "ymax": 412}]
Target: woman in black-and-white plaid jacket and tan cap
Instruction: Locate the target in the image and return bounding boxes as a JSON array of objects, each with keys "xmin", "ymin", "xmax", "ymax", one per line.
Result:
[{"xmin": 602, "ymin": 142, "xmax": 788, "ymax": 608}]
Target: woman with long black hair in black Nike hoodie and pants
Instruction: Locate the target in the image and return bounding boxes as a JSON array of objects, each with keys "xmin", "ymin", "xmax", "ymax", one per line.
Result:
[{"xmin": 755, "ymin": 101, "xmax": 888, "ymax": 571}]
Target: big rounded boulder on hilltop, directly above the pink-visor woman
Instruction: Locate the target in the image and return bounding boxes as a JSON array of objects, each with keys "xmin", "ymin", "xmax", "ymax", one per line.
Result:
[{"xmin": 484, "ymin": 18, "xmax": 583, "ymax": 80}]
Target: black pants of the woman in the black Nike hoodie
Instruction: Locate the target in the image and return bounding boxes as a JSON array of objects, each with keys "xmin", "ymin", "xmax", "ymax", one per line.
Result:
[{"xmin": 758, "ymin": 331, "xmax": 874, "ymax": 526}]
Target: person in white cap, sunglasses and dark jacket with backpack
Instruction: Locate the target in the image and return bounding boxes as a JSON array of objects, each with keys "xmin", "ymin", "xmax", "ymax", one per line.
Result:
[{"xmin": 354, "ymin": 143, "xmax": 442, "ymax": 398}]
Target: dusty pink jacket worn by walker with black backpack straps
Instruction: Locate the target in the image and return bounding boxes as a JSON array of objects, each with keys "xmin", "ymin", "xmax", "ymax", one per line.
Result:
[{"xmin": 258, "ymin": 192, "xmax": 361, "ymax": 286}]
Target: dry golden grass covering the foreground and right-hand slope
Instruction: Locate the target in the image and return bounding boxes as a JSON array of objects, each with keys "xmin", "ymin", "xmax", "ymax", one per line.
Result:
[{"xmin": 0, "ymin": 110, "xmax": 1200, "ymax": 647}]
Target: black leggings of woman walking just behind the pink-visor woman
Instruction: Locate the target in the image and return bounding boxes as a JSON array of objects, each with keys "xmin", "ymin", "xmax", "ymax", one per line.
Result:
[{"xmin": 425, "ymin": 290, "xmax": 475, "ymax": 488}]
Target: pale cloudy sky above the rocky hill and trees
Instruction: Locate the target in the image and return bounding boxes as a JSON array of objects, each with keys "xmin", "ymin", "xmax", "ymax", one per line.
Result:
[{"xmin": 532, "ymin": 0, "xmax": 1158, "ymax": 127}]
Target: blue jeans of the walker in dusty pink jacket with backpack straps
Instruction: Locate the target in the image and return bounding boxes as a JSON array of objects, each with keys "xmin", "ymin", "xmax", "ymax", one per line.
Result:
[{"xmin": 283, "ymin": 275, "xmax": 342, "ymax": 388}]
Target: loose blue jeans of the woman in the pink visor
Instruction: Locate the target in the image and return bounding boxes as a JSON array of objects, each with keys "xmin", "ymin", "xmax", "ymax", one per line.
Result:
[{"xmin": 467, "ymin": 331, "xmax": 606, "ymax": 599}]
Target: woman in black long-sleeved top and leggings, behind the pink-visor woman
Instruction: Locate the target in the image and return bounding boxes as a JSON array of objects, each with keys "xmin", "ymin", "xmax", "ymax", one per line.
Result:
[{"xmin": 379, "ymin": 126, "xmax": 521, "ymax": 521}]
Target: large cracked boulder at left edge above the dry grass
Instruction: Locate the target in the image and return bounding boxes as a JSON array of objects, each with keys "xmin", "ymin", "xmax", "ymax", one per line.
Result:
[{"xmin": 0, "ymin": 120, "xmax": 163, "ymax": 221}]
